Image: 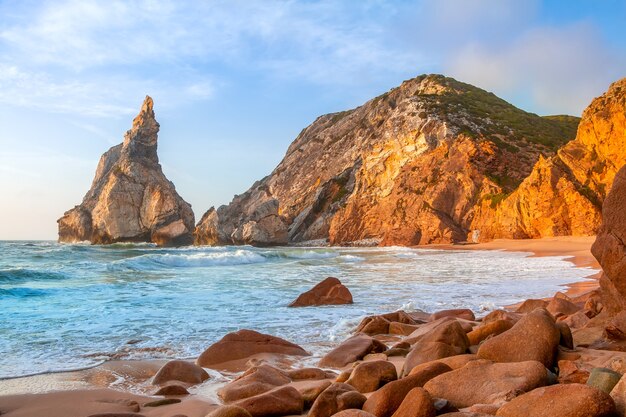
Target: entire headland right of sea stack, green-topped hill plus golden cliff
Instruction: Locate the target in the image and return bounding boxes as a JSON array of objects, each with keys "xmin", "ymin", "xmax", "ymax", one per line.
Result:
[{"xmin": 195, "ymin": 75, "xmax": 626, "ymax": 246}]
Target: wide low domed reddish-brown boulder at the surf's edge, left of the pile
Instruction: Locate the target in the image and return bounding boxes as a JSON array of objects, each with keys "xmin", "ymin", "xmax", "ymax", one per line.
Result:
[{"xmin": 196, "ymin": 330, "xmax": 309, "ymax": 368}]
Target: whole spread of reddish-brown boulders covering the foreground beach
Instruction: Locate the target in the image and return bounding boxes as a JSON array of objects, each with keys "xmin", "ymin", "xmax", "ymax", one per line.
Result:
[{"xmin": 118, "ymin": 286, "xmax": 626, "ymax": 417}]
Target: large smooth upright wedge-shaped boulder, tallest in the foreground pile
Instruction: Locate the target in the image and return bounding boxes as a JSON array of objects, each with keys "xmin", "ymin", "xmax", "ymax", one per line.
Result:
[{"xmin": 477, "ymin": 309, "xmax": 561, "ymax": 368}]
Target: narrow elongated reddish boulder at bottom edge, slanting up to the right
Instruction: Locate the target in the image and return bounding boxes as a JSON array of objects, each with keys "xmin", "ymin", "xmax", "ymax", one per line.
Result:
[{"xmin": 363, "ymin": 363, "xmax": 451, "ymax": 417}]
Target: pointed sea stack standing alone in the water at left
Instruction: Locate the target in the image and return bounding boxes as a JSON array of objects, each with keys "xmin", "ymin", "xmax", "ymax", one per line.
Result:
[{"xmin": 57, "ymin": 97, "xmax": 195, "ymax": 246}]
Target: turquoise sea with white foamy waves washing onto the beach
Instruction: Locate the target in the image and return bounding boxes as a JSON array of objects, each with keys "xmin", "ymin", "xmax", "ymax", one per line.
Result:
[{"xmin": 0, "ymin": 241, "xmax": 590, "ymax": 378}]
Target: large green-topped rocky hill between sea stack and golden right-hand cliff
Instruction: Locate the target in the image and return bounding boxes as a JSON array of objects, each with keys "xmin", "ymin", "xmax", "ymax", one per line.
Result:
[{"xmin": 195, "ymin": 75, "xmax": 578, "ymax": 245}]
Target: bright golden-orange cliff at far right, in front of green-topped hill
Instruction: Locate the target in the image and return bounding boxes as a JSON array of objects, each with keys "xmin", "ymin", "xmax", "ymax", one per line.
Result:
[{"xmin": 471, "ymin": 79, "xmax": 626, "ymax": 240}]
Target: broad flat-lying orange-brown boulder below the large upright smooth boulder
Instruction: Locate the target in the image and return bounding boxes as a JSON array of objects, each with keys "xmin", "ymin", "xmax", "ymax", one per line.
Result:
[{"xmin": 424, "ymin": 360, "xmax": 548, "ymax": 408}]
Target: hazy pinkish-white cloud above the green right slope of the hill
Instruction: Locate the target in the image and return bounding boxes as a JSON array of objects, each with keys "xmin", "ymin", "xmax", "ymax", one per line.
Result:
[{"xmin": 448, "ymin": 24, "xmax": 626, "ymax": 115}]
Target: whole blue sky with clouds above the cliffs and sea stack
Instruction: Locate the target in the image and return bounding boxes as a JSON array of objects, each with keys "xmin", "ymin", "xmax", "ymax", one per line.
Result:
[{"xmin": 0, "ymin": 0, "xmax": 626, "ymax": 239}]
